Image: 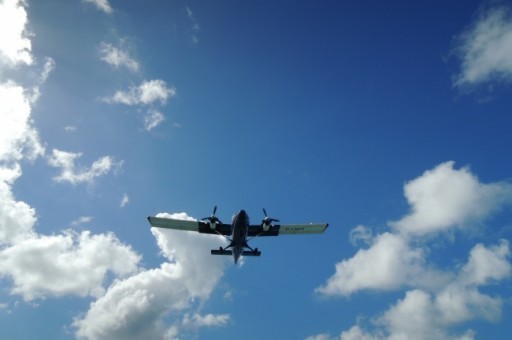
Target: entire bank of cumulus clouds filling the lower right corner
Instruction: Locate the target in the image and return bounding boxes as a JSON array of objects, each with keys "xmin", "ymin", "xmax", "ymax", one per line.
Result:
[{"xmin": 316, "ymin": 162, "xmax": 512, "ymax": 339}]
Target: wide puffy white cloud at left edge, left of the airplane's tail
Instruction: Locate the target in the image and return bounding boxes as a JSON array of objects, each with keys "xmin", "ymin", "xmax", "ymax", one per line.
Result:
[{"xmin": 0, "ymin": 231, "xmax": 140, "ymax": 301}]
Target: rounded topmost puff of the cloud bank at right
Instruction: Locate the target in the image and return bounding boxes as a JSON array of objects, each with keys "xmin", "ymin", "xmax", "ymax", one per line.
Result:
[{"xmin": 390, "ymin": 162, "xmax": 512, "ymax": 235}]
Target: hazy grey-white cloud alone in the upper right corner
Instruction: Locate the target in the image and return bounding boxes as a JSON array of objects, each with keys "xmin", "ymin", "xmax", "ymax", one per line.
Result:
[{"xmin": 454, "ymin": 6, "xmax": 512, "ymax": 86}]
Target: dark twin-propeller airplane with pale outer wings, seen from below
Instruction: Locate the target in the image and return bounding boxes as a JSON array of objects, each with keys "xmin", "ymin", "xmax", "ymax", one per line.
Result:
[{"xmin": 148, "ymin": 206, "xmax": 329, "ymax": 264}]
